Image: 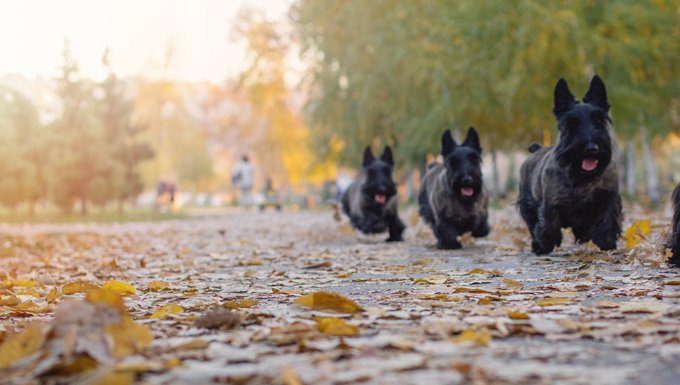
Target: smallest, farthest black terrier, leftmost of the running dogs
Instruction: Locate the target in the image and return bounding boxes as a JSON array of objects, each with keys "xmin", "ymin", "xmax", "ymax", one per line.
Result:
[{"xmin": 342, "ymin": 146, "xmax": 406, "ymax": 242}]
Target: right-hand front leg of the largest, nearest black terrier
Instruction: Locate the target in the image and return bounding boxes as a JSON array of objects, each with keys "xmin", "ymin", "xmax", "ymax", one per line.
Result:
[{"xmin": 590, "ymin": 192, "xmax": 623, "ymax": 250}]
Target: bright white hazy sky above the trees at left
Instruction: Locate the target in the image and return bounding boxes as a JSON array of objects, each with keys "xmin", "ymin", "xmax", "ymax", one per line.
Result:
[{"xmin": 0, "ymin": 0, "xmax": 291, "ymax": 81}]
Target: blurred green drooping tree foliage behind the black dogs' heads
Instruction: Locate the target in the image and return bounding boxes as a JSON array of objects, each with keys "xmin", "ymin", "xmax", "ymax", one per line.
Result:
[{"xmin": 292, "ymin": 0, "xmax": 680, "ymax": 164}]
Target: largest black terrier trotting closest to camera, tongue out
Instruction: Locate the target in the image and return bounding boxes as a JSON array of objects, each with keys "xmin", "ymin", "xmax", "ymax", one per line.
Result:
[{"xmin": 518, "ymin": 75, "xmax": 623, "ymax": 254}]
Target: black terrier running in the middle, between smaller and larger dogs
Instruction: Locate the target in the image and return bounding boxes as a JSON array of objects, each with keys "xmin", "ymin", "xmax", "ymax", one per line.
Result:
[{"xmin": 418, "ymin": 127, "xmax": 489, "ymax": 249}]
